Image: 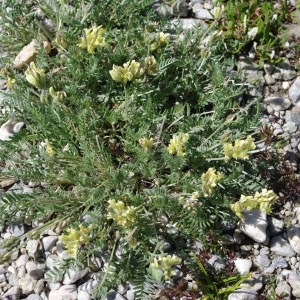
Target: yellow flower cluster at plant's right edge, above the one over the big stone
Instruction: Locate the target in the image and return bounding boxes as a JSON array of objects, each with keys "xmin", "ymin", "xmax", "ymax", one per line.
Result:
[{"xmin": 224, "ymin": 136, "xmax": 255, "ymax": 160}]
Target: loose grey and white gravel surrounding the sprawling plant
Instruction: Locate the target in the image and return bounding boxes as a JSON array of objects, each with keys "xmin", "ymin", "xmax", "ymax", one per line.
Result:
[{"xmin": 0, "ymin": 0, "xmax": 300, "ymax": 300}]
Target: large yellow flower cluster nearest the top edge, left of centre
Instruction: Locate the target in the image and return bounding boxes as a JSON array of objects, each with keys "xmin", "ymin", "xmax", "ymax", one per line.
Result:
[{"xmin": 78, "ymin": 26, "xmax": 105, "ymax": 54}]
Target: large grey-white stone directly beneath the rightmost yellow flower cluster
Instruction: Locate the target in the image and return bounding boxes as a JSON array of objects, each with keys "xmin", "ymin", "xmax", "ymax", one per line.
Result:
[{"xmin": 239, "ymin": 210, "xmax": 268, "ymax": 243}]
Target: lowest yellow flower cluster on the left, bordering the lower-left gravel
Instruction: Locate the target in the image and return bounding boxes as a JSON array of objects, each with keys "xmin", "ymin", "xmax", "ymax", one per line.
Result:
[{"xmin": 60, "ymin": 224, "xmax": 92, "ymax": 258}]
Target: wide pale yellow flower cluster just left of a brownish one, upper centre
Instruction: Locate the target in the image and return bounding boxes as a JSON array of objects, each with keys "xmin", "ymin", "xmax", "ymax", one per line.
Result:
[{"xmin": 109, "ymin": 60, "xmax": 144, "ymax": 84}]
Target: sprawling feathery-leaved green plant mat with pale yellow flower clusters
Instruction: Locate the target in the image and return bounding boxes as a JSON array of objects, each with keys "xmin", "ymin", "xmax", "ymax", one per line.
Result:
[{"xmin": 0, "ymin": 0, "xmax": 296, "ymax": 299}]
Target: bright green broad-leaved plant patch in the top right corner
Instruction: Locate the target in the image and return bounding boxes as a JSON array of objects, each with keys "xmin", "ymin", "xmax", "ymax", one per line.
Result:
[{"xmin": 218, "ymin": 0, "xmax": 292, "ymax": 63}]
